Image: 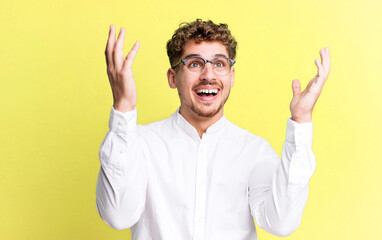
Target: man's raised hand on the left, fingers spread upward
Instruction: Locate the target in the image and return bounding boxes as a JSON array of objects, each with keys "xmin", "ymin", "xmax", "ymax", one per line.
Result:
[{"xmin": 105, "ymin": 25, "xmax": 140, "ymax": 112}]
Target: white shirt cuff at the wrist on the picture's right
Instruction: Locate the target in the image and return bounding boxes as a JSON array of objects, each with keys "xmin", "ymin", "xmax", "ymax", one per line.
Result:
[{"xmin": 286, "ymin": 118, "xmax": 313, "ymax": 146}]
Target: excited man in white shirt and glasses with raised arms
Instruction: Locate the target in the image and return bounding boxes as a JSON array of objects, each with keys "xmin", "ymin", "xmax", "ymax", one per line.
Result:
[{"xmin": 96, "ymin": 19, "xmax": 330, "ymax": 240}]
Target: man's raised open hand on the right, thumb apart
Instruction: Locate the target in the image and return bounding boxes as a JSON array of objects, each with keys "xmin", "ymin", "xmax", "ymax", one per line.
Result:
[{"xmin": 290, "ymin": 47, "xmax": 330, "ymax": 123}]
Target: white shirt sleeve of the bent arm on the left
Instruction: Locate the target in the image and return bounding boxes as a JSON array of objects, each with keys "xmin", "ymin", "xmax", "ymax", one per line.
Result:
[{"xmin": 96, "ymin": 107, "xmax": 148, "ymax": 230}]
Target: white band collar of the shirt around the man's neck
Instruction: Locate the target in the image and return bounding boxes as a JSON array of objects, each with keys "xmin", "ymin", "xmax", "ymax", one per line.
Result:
[{"xmin": 172, "ymin": 107, "xmax": 227, "ymax": 139}]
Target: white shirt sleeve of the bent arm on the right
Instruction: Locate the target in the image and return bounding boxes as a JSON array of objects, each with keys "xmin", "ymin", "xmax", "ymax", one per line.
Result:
[{"xmin": 249, "ymin": 119, "xmax": 316, "ymax": 236}]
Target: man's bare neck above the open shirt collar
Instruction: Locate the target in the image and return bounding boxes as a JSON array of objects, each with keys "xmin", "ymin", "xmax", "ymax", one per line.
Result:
[{"xmin": 179, "ymin": 107, "xmax": 223, "ymax": 138}]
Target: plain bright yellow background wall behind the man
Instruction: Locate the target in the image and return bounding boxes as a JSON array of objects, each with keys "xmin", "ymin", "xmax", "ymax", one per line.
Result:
[{"xmin": 0, "ymin": 0, "xmax": 382, "ymax": 240}]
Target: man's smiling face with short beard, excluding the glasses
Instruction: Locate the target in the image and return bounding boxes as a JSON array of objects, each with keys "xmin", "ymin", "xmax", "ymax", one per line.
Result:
[{"xmin": 167, "ymin": 41, "xmax": 235, "ymax": 118}]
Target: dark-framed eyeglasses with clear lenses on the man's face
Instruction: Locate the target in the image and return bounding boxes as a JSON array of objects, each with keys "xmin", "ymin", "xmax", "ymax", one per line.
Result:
[{"xmin": 171, "ymin": 56, "xmax": 236, "ymax": 76}]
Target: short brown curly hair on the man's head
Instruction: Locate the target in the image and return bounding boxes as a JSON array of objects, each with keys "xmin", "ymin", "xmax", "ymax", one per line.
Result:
[{"xmin": 167, "ymin": 19, "xmax": 237, "ymax": 66}]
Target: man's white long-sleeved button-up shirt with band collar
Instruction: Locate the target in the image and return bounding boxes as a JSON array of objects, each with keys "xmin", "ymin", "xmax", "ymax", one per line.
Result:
[{"xmin": 96, "ymin": 108, "xmax": 316, "ymax": 240}]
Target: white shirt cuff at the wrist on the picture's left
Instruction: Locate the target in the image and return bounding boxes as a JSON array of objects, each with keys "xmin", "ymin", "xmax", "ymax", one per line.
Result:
[{"xmin": 109, "ymin": 106, "xmax": 137, "ymax": 134}]
